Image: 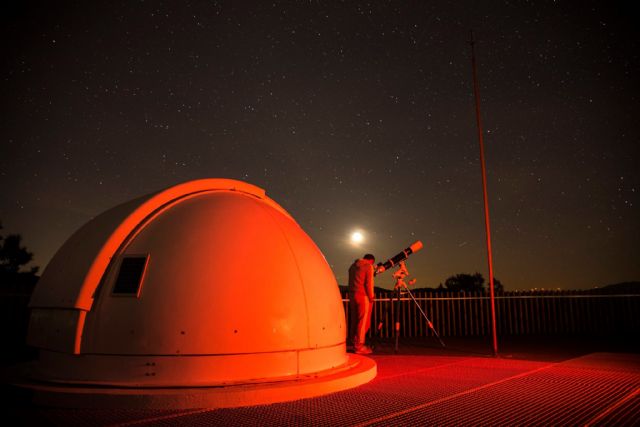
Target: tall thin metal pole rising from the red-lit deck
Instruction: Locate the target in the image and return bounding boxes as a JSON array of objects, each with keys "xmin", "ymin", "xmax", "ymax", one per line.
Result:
[{"xmin": 469, "ymin": 31, "xmax": 498, "ymax": 356}]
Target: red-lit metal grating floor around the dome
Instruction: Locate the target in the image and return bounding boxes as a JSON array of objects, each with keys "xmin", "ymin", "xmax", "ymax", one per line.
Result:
[{"xmin": 10, "ymin": 353, "xmax": 640, "ymax": 426}]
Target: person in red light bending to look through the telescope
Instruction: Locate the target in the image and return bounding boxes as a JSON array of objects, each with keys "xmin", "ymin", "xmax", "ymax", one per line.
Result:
[{"xmin": 349, "ymin": 254, "xmax": 376, "ymax": 354}]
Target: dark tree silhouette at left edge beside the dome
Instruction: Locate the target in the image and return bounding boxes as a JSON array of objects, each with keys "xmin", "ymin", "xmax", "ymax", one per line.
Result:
[{"xmin": 0, "ymin": 223, "xmax": 39, "ymax": 288}]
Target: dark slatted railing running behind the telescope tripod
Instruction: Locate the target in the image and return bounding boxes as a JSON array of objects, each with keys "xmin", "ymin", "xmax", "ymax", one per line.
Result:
[{"xmin": 343, "ymin": 291, "xmax": 640, "ymax": 338}]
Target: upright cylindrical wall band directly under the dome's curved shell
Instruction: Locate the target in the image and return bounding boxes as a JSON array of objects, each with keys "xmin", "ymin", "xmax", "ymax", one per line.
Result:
[{"xmin": 31, "ymin": 342, "xmax": 349, "ymax": 388}]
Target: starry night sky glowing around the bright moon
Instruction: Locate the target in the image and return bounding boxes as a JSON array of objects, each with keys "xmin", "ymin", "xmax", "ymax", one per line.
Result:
[{"xmin": 0, "ymin": 1, "xmax": 640, "ymax": 290}]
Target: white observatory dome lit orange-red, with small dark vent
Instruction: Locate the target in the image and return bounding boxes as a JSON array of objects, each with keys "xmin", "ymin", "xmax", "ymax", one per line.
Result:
[{"xmin": 28, "ymin": 179, "xmax": 375, "ymax": 400}]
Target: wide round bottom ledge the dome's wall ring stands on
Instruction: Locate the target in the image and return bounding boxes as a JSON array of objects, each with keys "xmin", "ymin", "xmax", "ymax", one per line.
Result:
[{"xmin": 14, "ymin": 354, "xmax": 377, "ymax": 409}]
